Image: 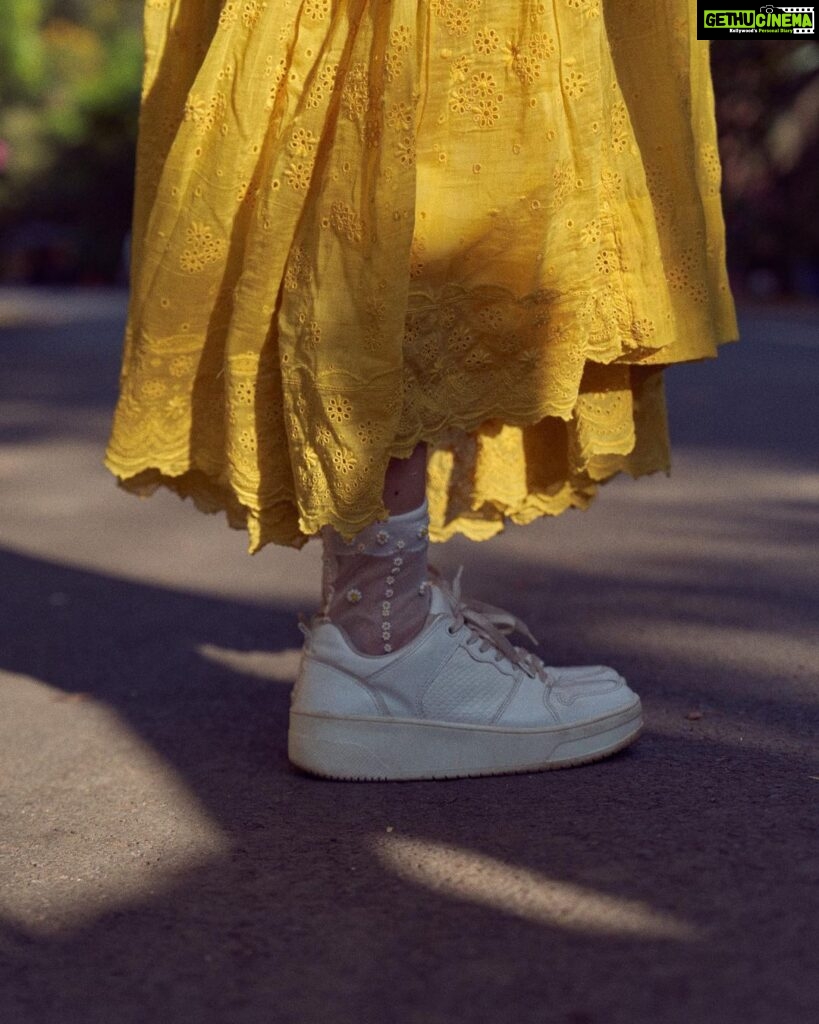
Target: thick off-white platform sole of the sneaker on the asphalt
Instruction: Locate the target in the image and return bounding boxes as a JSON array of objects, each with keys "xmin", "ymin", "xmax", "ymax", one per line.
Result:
[{"xmin": 288, "ymin": 699, "xmax": 643, "ymax": 782}]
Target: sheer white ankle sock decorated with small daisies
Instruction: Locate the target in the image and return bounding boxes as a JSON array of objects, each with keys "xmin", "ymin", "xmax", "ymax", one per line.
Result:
[{"xmin": 321, "ymin": 501, "xmax": 429, "ymax": 654}]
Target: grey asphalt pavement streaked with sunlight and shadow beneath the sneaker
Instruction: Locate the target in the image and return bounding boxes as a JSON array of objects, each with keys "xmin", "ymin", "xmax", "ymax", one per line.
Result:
[{"xmin": 0, "ymin": 290, "xmax": 819, "ymax": 1024}]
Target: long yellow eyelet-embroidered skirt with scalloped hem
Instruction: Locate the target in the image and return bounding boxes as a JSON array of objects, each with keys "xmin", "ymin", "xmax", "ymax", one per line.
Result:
[{"xmin": 105, "ymin": 0, "xmax": 737, "ymax": 552}]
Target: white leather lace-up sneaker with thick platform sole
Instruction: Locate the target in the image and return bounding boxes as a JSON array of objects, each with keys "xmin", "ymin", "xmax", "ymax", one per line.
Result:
[{"xmin": 288, "ymin": 573, "xmax": 643, "ymax": 780}]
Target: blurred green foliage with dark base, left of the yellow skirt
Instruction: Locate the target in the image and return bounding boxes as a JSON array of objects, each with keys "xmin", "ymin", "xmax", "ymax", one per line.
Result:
[{"xmin": 0, "ymin": 0, "xmax": 142, "ymax": 281}]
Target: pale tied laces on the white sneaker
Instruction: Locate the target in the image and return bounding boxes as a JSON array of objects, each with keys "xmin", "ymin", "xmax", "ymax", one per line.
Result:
[{"xmin": 429, "ymin": 565, "xmax": 554, "ymax": 685}]
